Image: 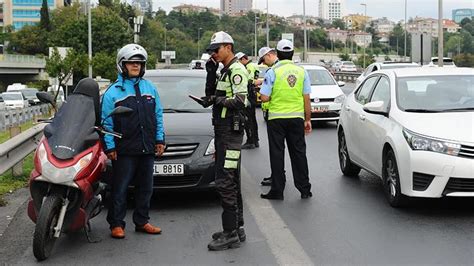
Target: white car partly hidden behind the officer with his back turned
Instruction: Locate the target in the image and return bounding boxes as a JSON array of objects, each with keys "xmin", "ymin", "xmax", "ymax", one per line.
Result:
[{"xmin": 301, "ymin": 64, "xmax": 346, "ymax": 121}]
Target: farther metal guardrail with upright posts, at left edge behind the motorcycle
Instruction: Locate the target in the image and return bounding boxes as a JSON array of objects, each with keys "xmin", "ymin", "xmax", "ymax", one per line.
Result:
[{"xmin": 0, "ymin": 104, "xmax": 49, "ymax": 132}]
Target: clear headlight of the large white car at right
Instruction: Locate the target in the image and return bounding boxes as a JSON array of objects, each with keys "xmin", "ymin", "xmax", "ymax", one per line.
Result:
[{"xmin": 403, "ymin": 128, "xmax": 461, "ymax": 156}]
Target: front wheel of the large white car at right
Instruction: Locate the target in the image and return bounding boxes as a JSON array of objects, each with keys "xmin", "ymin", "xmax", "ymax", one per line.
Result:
[{"xmin": 382, "ymin": 149, "xmax": 407, "ymax": 207}]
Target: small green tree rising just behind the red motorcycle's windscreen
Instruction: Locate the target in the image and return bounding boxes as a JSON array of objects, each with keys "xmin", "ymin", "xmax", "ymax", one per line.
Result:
[{"xmin": 45, "ymin": 47, "xmax": 89, "ymax": 101}]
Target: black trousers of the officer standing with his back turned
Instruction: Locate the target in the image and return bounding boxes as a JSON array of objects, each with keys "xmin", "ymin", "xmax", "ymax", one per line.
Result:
[{"xmin": 267, "ymin": 118, "xmax": 311, "ymax": 194}]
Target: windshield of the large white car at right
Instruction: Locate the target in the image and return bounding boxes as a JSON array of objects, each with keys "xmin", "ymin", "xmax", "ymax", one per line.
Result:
[{"xmin": 397, "ymin": 75, "xmax": 474, "ymax": 112}]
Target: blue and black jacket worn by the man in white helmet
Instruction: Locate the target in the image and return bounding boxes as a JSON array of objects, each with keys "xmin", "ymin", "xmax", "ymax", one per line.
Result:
[{"xmin": 102, "ymin": 75, "xmax": 165, "ymax": 155}]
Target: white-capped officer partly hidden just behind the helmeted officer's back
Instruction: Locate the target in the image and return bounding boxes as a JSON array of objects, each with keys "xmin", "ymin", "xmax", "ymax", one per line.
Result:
[{"xmin": 235, "ymin": 52, "xmax": 260, "ymax": 149}]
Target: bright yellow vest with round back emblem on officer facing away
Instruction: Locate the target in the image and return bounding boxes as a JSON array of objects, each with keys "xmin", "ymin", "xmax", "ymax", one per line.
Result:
[{"xmin": 268, "ymin": 60, "xmax": 305, "ymax": 120}]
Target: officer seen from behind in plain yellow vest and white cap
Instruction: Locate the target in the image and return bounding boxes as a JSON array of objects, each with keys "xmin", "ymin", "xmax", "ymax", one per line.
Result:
[{"xmin": 260, "ymin": 40, "xmax": 312, "ymax": 200}]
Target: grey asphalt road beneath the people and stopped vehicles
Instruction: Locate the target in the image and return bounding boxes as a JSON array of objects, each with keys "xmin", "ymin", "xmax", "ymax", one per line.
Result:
[{"xmin": 0, "ymin": 83, "xmax": 474, "ymax": 265}]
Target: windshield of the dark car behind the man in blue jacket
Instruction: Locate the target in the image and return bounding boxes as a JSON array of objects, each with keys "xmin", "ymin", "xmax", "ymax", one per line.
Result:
[{"xmin": 149, "ymin": 76, "xmax": 210, "ymax": 112}]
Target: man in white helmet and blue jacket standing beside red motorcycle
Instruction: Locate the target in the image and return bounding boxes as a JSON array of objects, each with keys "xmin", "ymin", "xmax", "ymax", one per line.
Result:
[{"xmin": 102, "ymin": 44, "xmax": 165, "ymax": 238}]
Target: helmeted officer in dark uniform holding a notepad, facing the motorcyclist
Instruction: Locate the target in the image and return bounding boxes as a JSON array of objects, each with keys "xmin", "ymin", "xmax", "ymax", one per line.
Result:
[{"xmin": 202, "ymin": 31, "xmax": 248, "ymax": 250}]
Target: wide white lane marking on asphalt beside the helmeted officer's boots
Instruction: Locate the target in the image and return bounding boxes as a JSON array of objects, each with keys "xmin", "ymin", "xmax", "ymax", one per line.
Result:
[{"xmin": 241, "ymin": 167, "xmax": 314, "ymax": 265}]
